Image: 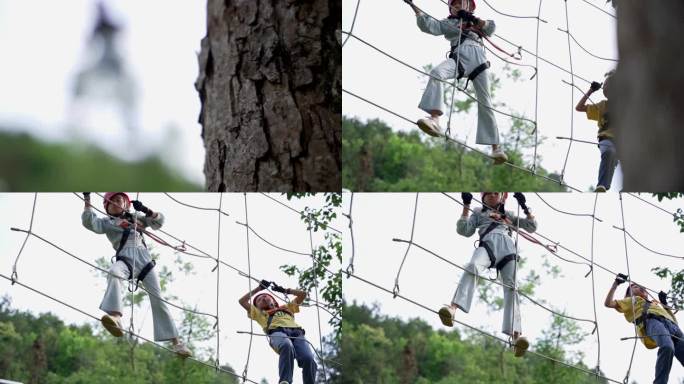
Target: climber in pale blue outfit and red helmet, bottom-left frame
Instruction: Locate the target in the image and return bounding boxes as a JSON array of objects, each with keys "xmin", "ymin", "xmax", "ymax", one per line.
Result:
[{"xmin": 81, "ymin": 192, "xmax": 191, "ymax": 358}]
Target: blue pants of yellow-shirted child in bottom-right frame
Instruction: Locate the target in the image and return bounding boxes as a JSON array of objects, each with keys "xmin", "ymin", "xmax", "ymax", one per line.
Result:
[{"xmin": 646, "ymin": 318, "xmax": 684, "ymax": 384}]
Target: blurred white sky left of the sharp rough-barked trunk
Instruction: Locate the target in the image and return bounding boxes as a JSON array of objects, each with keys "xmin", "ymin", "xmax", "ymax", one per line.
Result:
[{"xmin": 0, "ymin": 0, "xmax": 206, "ymax": 184}]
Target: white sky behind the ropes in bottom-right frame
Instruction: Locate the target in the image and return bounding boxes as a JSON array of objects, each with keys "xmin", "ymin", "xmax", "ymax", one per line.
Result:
[{"xmin": 342, "ymin": 193, "xmax": 684, "ymax": 384}]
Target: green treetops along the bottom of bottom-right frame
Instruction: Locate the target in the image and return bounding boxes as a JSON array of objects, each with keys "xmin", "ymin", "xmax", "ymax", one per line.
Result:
[{"xmin": 335, "ymin": 303, "xmax": 606, "ymax": 384}]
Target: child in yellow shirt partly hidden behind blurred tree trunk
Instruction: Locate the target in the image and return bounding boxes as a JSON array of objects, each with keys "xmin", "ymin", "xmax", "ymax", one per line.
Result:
[{"xmin": 575, "ymin": 72, "xmax": 618, "ymax": 192}]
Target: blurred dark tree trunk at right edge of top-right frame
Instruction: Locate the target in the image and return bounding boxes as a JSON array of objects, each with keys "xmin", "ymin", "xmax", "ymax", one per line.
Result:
[{"xmin": 611, "ymin": 0, "xmax": 684, "ymax": 192}]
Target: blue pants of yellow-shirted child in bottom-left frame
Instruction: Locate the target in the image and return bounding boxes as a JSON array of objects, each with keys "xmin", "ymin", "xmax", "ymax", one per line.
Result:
[{"xmin": 268, "ymin": 328, "xmax": 318, "ymax": 384}]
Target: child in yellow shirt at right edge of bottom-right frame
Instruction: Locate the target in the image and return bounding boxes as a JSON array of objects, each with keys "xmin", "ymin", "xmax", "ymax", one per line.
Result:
[{"xmin": 604, "ymin": 274, "xmax": 684, "ymax": 384}]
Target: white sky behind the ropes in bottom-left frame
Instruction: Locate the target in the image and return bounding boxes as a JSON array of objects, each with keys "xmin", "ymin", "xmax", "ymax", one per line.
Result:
[{"xmin": 0, "ymin": 193, "xmax": 341, "ymax": 383}]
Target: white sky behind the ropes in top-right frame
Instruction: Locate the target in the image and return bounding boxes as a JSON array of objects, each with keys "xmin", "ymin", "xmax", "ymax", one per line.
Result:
[{"xmin": 342, "ymin": 0, "xmax": 622, "ymax": 190}]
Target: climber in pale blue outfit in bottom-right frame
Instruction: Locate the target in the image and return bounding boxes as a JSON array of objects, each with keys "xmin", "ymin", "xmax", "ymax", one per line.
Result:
[{"xmin": 439, "ymin": 192, "xmax": 537, "ymax": 357}]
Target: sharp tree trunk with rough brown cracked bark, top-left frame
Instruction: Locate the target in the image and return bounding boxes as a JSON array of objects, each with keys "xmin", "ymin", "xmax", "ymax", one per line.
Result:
[{"xmin": 195, "ymin": 0, "xmax": 342, "ymax": 192}]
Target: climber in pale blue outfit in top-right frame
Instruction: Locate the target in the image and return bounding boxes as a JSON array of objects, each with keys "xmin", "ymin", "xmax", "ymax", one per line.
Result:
[{"xmin": 404, "ymin": 0, "xmax": 508, "ymax": 164}]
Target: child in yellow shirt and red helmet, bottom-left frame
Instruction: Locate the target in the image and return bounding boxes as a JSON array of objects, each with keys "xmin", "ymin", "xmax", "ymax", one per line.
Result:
[{"xmin": 239, "ymin": 280, "xmax": 318, "ymax": 384}]
